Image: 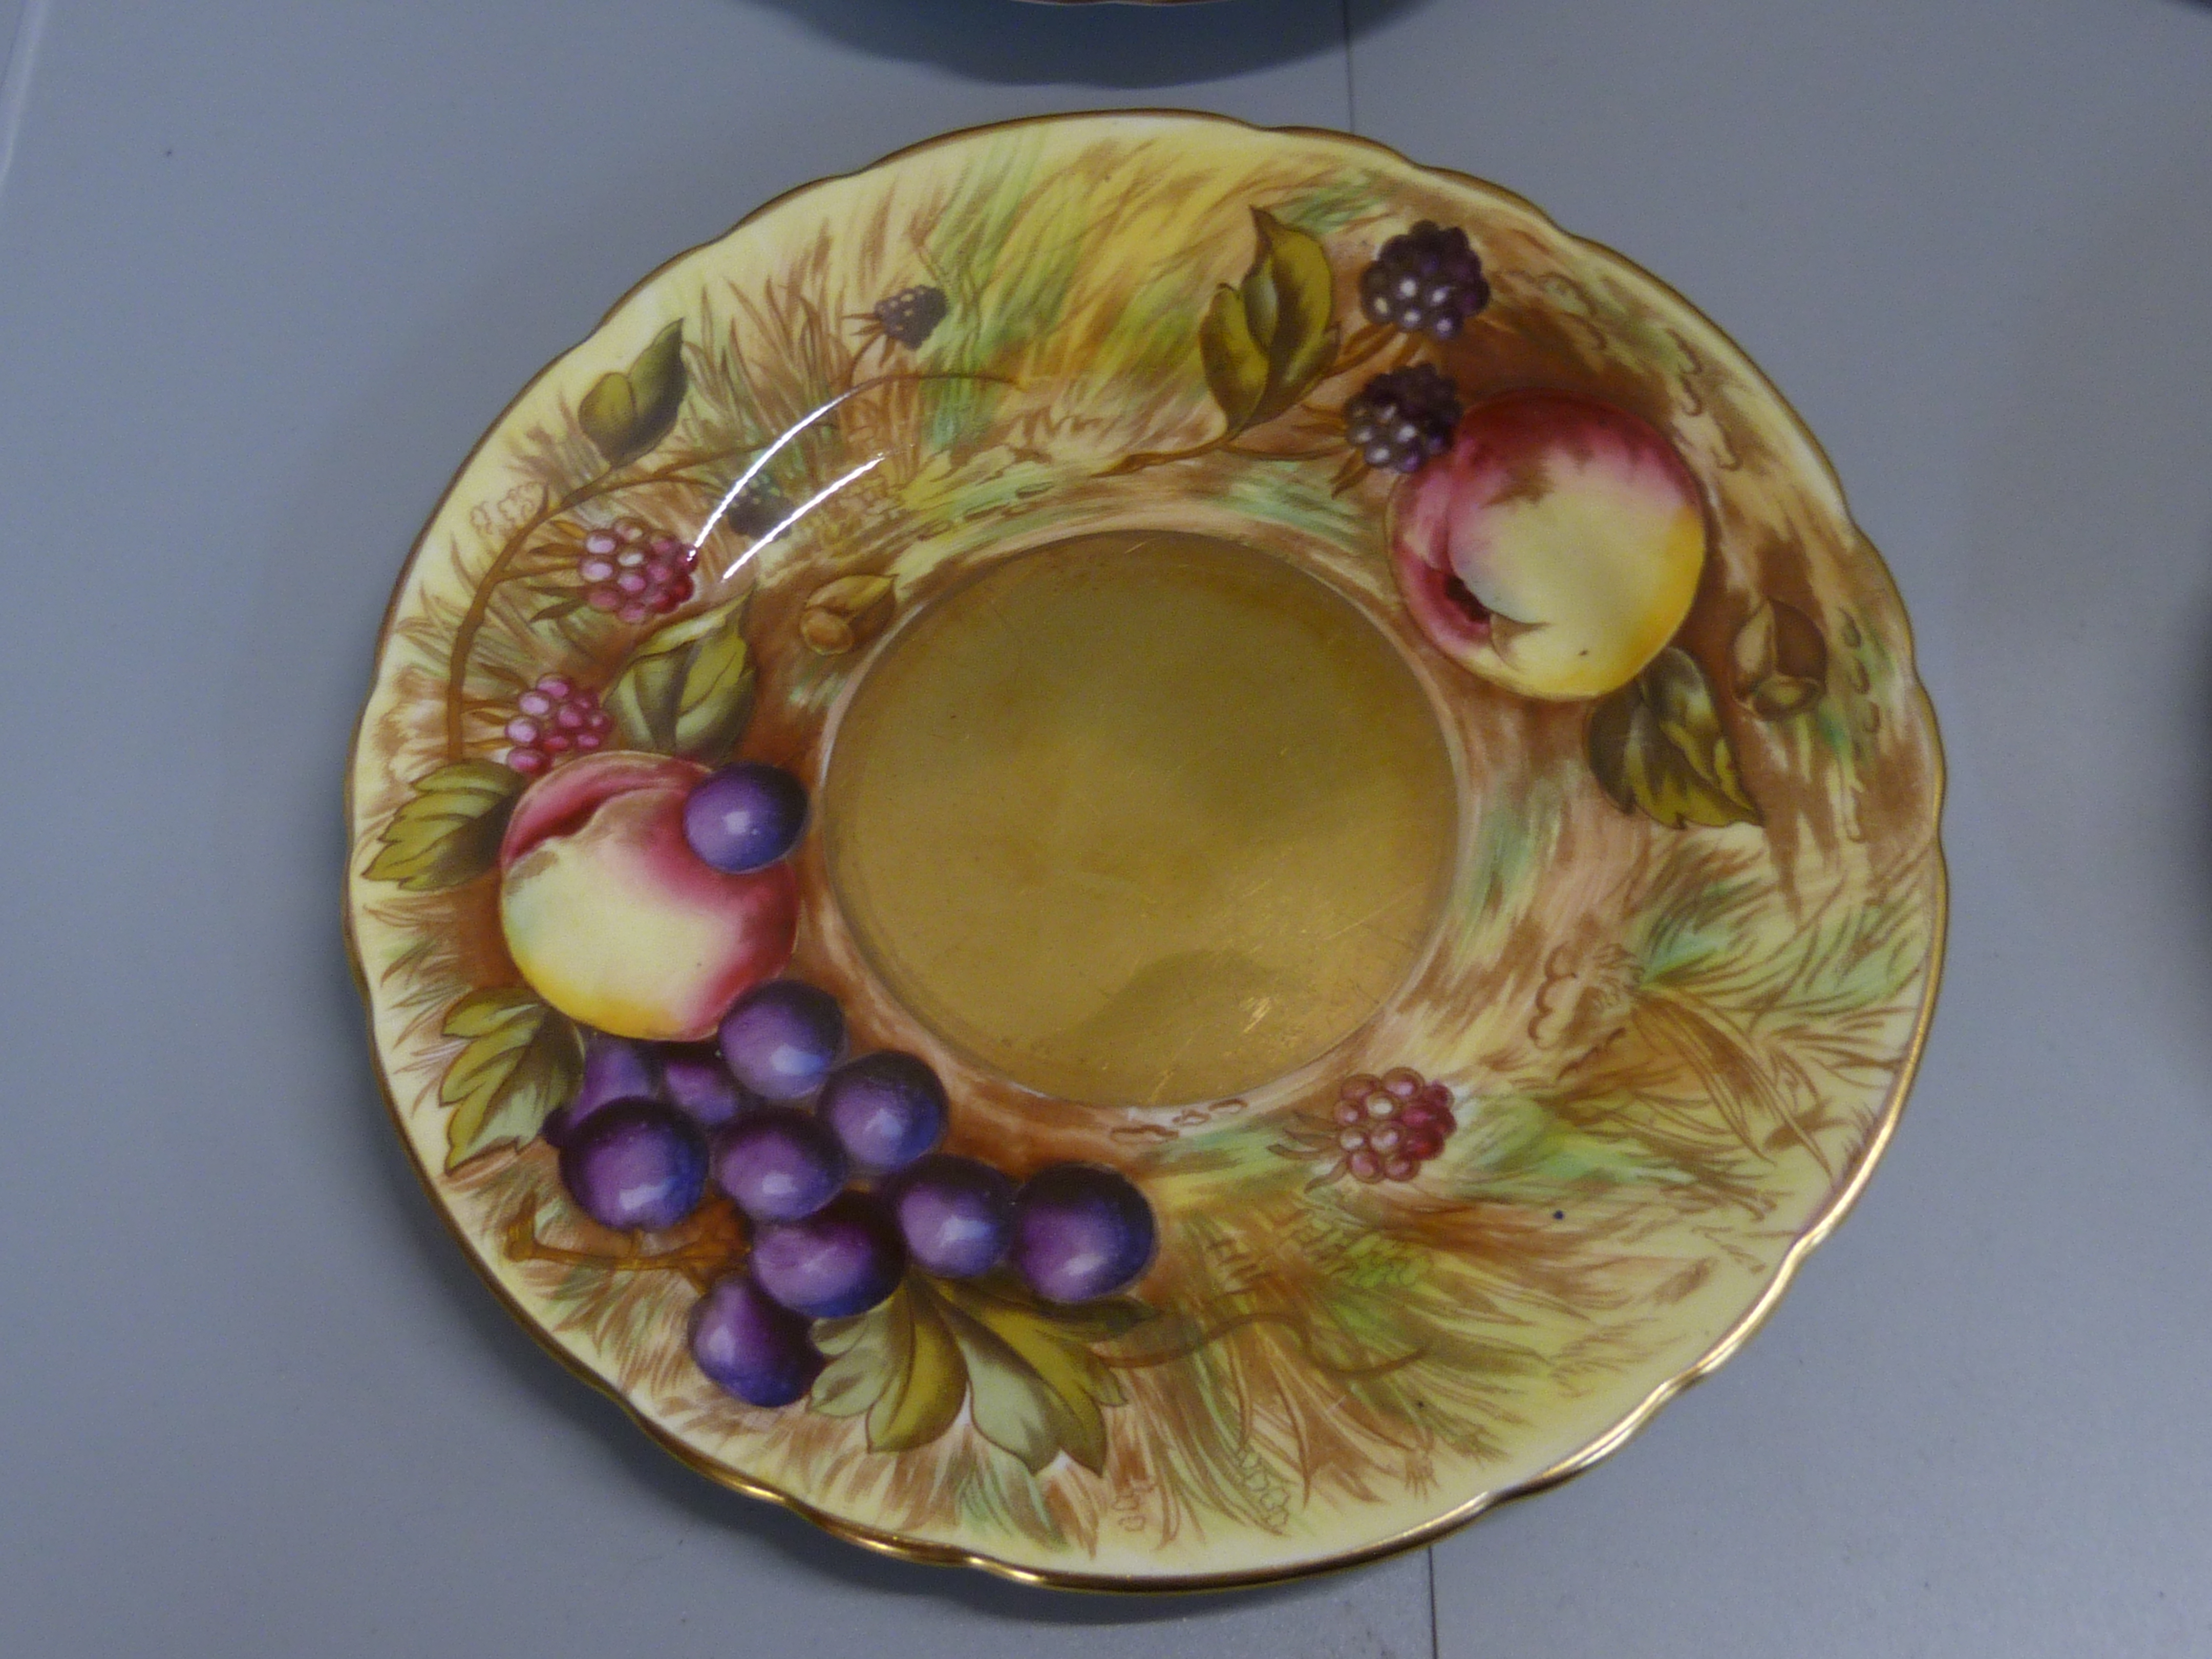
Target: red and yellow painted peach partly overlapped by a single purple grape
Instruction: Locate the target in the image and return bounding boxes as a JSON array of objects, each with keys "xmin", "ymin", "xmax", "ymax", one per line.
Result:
[{"xmin": 500, "ymin": 752, "xmax": 799, "ymax": 1042}]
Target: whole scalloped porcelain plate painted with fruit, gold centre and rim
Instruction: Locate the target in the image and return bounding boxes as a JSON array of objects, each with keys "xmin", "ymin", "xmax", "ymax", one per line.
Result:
[{"xmin": 347, "ymin": 113, "xmax": 1944, "ymax": 1588}]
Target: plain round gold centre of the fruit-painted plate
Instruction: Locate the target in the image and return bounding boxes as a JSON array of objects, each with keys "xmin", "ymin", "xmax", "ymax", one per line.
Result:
[{"xmin": 823, "ymin": 533, "xmax": 1456, "ymax": 1106}]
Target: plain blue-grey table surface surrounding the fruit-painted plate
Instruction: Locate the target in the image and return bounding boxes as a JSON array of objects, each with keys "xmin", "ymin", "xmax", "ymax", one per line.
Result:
[{"xmin": 0, "ymin": 0, "xmax": 2212, "ymax": 1659}]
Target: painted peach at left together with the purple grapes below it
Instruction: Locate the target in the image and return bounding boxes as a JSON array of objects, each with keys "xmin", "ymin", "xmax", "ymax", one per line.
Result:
[{"xmin": 498, "ymin": 734, "xmax": 1159, "ymax": 1424}]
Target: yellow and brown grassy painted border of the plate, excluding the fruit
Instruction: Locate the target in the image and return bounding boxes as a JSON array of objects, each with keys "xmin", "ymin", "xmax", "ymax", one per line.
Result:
[{"xmin": 345, "ymin": 111, "xmax": 1947, "ymax": 1590}]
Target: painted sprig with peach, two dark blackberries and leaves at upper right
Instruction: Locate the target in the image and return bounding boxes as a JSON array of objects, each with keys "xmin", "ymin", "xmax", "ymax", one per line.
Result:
[{"xmin": 1111, "ymin": 208, "xmax": 1858, "ymax": 827}]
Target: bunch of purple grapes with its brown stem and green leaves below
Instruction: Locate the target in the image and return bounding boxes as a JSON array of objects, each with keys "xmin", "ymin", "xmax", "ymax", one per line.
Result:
[{"xmin": 506, "ymin": 955, "xmax": 1157, "ymax": 1471}]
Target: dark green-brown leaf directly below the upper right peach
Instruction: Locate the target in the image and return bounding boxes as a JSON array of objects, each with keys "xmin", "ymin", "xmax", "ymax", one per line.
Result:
[{"xmin": 1588, "ymin": 646, "xmax": 1758, "ymax": 830}]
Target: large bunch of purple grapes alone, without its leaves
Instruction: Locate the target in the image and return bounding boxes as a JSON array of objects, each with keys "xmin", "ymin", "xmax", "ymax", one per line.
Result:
[{"xmin": 544, "ymin": 960, "xmax": 1157, "ymax": 1407}]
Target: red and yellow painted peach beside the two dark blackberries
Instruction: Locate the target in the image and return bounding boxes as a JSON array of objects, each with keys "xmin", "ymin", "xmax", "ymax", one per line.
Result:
[{"xmin": 1391, "ymin": 392, "xmax": 1706, "ymax": 701}]
